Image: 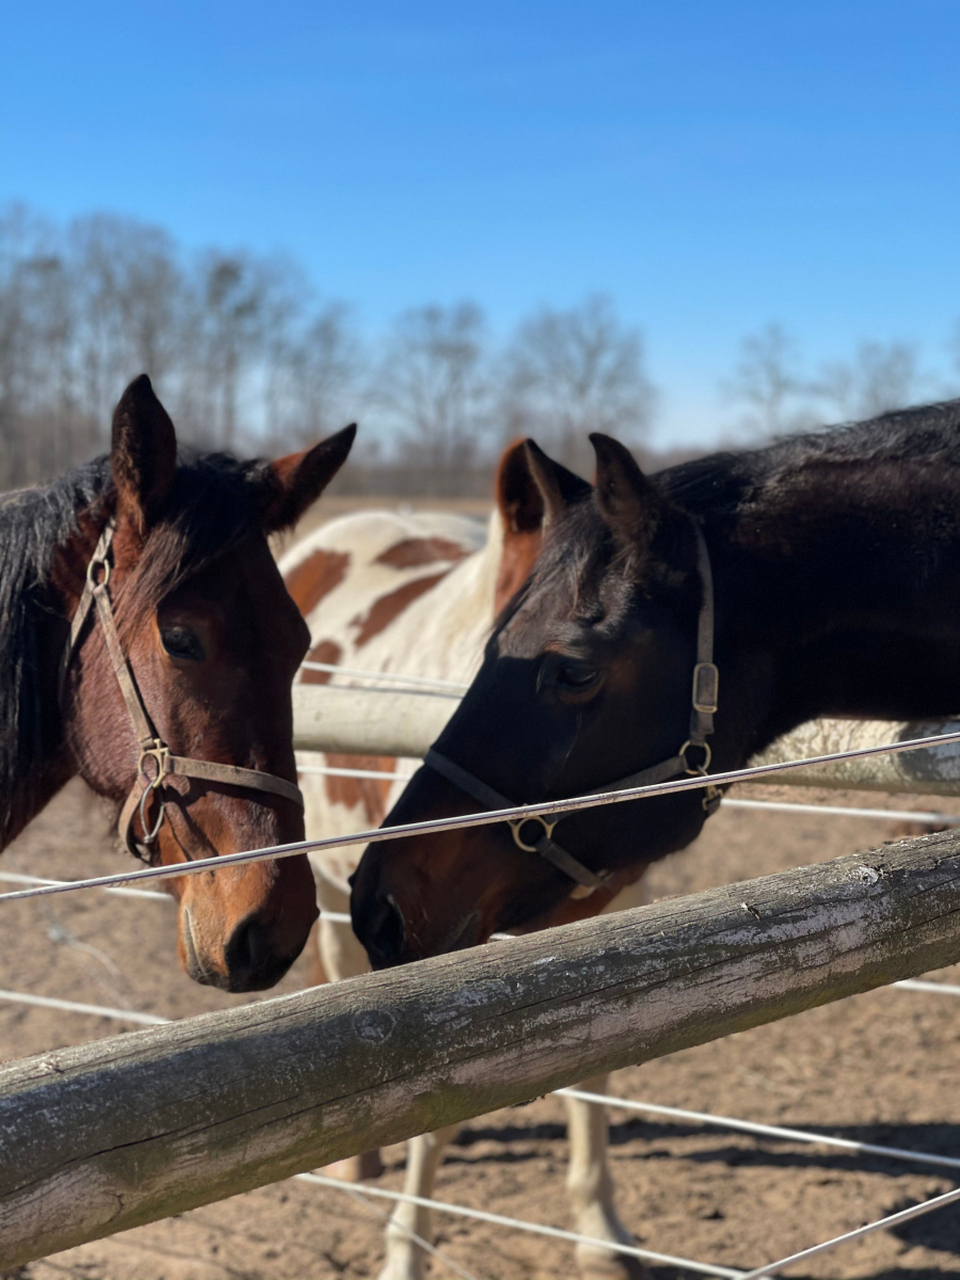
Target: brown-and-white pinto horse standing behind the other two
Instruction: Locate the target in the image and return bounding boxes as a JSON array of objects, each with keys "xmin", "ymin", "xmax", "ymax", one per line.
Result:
[{"xmin": 280, "ymin": 443, "xmax": 647, "ymax": 1280}]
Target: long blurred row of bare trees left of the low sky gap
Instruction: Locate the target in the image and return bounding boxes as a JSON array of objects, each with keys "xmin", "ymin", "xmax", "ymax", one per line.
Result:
[{"xmin": 0, "ymin": 206, "xmax": 654, "ymax": 492}]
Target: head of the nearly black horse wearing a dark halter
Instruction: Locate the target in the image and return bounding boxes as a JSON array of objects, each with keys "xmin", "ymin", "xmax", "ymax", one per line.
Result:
[{"xmin": 352, "ymin": 435, "xmax": 721, "ymax": 968}]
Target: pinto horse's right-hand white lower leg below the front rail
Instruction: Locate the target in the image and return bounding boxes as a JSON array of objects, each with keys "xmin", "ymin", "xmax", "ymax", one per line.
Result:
[{"xmin": 564, "ymin": 1075, "xmax": 649, "ymax": 1280}]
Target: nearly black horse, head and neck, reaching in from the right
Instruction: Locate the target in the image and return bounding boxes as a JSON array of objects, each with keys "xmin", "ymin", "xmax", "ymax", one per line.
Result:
[{"xmin": 352, "ymin": 401, "xmax": 960, "ymax": 966}]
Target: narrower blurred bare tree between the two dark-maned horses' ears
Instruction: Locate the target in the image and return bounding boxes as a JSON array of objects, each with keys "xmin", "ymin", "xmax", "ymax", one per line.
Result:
[{"xmin": 375, "ymin": 302, "xmax": 489, "ymax": 488}]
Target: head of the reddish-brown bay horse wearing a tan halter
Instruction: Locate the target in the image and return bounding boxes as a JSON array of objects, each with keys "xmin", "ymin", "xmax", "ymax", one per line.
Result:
[{"xmin": 52, "ymin": 376, "xmax": 355, "ymax": 991}]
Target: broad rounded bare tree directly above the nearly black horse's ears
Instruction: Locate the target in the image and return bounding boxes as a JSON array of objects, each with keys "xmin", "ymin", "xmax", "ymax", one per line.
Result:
[{"xmin": 500, "ymin": 294, "xmax": 657, "ymax": 470}]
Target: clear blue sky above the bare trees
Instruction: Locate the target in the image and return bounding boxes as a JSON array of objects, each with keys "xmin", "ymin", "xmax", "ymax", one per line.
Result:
[{"xmin": 0, "ymin": 0, "xmax": 960, "ymax": 443}]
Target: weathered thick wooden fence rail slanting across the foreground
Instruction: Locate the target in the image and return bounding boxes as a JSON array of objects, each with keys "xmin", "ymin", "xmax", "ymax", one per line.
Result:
[{"xmin": 0, "ymin": 832, "xmax": 960, "ymax": 1267}]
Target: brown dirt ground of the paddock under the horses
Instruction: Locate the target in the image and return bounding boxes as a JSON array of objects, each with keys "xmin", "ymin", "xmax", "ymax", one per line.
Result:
[{"xmin": 0, "ymin": 785, "xmax": 960, "ymax": 1280}]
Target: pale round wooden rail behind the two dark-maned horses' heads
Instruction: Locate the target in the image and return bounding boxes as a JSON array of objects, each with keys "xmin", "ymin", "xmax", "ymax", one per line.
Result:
[{"xmin": 293, "ymin": 685, "xmax": 960, "ymax": 795}]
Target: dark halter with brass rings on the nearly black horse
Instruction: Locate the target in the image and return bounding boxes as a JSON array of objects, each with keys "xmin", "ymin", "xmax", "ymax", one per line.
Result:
[{"xmin": 424, "ymin": 516, "xmax": 721, "ymax": 896}]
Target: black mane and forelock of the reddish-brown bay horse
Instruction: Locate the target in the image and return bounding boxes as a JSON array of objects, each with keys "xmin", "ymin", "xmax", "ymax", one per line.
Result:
[{"xmin": 0, "ymin": 454, "xmax": 268, "ymax": 849}]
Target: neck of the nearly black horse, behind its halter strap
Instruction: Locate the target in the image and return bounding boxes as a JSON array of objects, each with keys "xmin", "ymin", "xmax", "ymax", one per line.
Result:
[{"xmin": 705, "ymin": 463, "xmax": 960, "ymax": 754}]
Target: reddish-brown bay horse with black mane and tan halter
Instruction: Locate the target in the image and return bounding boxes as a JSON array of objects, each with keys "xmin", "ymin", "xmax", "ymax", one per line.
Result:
[{"xmin": 0, "ymin": 375, "xmax": 355, "ymax": 991}]
